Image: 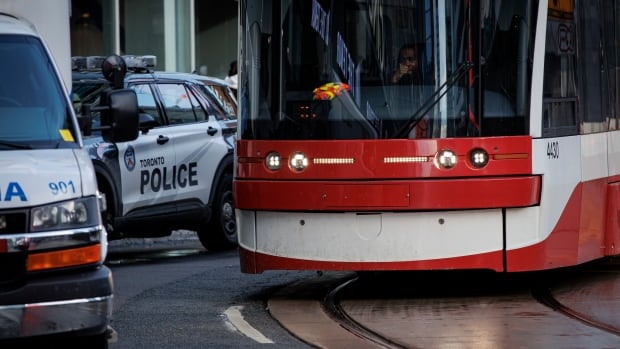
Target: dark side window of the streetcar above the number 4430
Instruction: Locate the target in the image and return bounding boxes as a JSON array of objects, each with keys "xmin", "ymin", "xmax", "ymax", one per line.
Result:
[{"xmin": 542, "ymin": 1, "xmax": 620, "ymax": 137}]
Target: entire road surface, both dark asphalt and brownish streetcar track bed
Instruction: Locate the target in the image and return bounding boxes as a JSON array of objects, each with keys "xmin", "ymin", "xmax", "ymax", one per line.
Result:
[{"xmin": 108, "ymin": 231, "xmax": 620, "ymax": 349}]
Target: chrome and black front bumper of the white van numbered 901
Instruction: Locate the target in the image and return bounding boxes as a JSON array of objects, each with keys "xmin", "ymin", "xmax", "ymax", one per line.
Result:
[{"xmin": 0, "ymin": 266, "xmax": 113, "ymax": 338}]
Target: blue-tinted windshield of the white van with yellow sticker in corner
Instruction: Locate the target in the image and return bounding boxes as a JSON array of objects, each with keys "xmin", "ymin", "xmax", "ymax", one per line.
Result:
[{"xmin": 0, "ymin": 35, "xmax": 78, "ymax": 149}]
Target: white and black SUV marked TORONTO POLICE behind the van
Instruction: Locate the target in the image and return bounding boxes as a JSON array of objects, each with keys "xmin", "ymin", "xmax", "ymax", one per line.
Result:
[{"xmin": 72, "ymin": 56, "xmax": 237, "ymax": 251}]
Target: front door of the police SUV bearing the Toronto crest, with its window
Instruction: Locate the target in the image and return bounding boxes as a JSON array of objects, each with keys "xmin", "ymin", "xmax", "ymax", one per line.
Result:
[{"xmin": 118, "ymin": 83, "xmax": 176, "ymax": 215}]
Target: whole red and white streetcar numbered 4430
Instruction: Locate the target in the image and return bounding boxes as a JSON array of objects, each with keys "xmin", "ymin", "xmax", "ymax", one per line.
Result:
[{"xmin": 234, "ymin": 0, "xmax": 620, "ymax": 273}]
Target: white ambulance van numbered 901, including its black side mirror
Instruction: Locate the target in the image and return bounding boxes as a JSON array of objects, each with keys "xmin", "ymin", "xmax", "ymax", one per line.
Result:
[{"xmin": 0, "ymin": 0, "xmax": 138, "ymax": 348}]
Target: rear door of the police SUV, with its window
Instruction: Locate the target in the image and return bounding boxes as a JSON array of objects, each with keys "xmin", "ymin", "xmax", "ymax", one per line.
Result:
[{"xmin": 153, "ymin": 81, "xmax": 227, "ymax": 204}]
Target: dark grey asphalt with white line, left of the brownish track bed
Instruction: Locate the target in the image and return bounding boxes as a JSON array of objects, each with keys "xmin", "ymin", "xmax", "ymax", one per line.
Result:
[{"xmin": 107, "ymin": 231, "xmax": 316, "ymax": 349}]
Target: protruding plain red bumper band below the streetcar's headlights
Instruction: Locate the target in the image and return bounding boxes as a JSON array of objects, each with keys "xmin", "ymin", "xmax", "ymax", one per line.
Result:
[{"xmin": 234, "ymin": 176, "xmax": 541, "ymax": 211}]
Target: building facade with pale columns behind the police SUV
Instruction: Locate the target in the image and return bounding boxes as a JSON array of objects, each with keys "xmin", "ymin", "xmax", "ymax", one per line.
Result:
[{"xmin": 71, "ymin": 0, "xmax": 238, "ymax": 78}]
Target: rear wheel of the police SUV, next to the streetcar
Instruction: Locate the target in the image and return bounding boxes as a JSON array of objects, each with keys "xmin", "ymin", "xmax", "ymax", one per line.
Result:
[{"xmin": 197, "ymin": 173, "xmax": 237, "ymax": 251}]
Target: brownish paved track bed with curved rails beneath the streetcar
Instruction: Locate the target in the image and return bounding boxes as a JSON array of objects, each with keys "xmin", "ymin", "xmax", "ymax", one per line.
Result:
[{"xmin": 269, "ymin": 260, "xmax": 620, "ymax": 349}]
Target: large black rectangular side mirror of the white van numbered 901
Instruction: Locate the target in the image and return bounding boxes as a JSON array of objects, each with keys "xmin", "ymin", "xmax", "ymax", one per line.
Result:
[{"xmin": 97, "ymin": 89, "xmax": 139, "ymax": 143}]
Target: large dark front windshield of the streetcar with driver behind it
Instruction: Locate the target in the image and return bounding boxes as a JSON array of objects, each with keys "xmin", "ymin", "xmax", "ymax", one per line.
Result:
[{"xmin": 239, "ymin": 0, "xmax": 538, "ymax": 140}]
